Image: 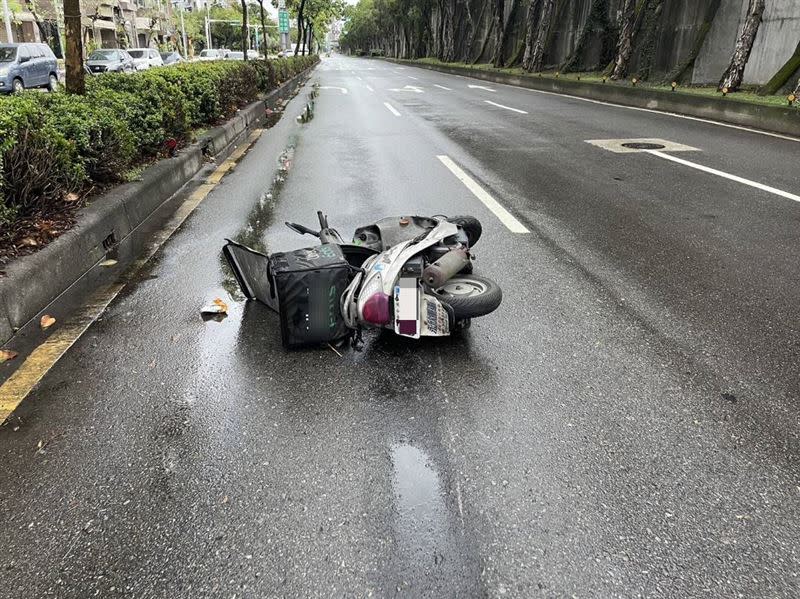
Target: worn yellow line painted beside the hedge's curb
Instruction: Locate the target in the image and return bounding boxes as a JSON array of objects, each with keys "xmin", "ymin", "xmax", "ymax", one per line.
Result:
[{"xmin": 0, "ymin": 129, "xmax": 263, "ymax": 424}]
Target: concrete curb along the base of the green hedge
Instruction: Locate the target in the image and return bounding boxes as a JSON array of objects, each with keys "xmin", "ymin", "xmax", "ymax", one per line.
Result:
[{"xmin": 0, "ymin": 65, "xmax": 316, "ymax": 345}]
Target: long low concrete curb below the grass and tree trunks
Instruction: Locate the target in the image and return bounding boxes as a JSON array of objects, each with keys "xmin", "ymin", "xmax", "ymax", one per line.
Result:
[{"xmin": 383, "ymin": 58, "xmax": 800, "ymax": 137}]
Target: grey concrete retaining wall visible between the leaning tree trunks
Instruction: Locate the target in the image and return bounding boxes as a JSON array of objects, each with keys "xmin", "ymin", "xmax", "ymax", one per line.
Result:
[{"xmin": 434, "ymin": 0, "xmax": 800, "ymax": 85}]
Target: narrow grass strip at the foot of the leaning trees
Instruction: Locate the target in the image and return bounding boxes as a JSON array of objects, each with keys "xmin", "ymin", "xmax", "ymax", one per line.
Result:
[{"xmin": 410, "ymin": 58, "xmax": 800, "ymax": 109}]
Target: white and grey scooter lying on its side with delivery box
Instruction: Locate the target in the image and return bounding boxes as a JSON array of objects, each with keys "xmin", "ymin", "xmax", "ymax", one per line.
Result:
[{"xmin": 224, "ymin": 212, "xmax": 503, "ymax": 347}]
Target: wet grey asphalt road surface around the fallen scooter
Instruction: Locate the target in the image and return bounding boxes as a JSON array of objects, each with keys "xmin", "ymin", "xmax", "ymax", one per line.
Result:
[{"xmin": 0, "ymin": 57, "xmax": 800, "ymax": 598}]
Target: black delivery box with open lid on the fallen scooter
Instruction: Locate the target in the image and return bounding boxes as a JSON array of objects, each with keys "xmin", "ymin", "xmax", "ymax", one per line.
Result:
[{"xmin": 223, "ymin": 240, "xmax": 350, "ymax": 348}]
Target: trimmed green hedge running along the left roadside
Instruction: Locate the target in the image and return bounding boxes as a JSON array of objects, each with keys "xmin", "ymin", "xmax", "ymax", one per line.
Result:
[{"xmin": 0, "ymin": 56, "xmax": 318, "ymax": 232}]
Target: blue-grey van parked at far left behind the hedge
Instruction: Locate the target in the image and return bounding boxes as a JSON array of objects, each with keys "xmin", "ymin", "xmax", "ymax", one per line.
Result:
[{"xmin": 0, "ymin": 43, "xmax": 58, "ymax": 93}]
